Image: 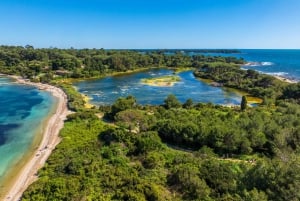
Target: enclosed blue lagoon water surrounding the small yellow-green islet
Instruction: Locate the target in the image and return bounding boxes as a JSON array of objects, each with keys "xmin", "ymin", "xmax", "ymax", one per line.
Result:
[{"xmin": 75, "ymin": 69, "xmax": 241, "ymax": 105}]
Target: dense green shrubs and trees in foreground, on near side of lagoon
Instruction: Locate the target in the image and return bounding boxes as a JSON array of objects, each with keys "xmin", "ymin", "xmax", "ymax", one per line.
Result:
[{"xmin": 22, "ymin": 95, "xmax": 300, "ymax": 201}]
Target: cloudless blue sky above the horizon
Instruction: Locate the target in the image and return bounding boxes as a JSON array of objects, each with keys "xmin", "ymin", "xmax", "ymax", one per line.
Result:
[{"xmin": 0, "ymin": 0, "xmax": 300, "ymax": 49}]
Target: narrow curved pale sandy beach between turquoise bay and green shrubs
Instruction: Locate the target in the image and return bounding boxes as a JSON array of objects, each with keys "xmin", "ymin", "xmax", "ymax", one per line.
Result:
[{"xmin": 0, "ymin": 75, "xmax": 70, "ymax": 201}]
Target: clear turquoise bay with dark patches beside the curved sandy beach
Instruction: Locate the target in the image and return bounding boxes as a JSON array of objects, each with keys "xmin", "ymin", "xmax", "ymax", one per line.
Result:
[{"xmin": 0, "ymin": 77, "xmax": 56, "ymax": 183}]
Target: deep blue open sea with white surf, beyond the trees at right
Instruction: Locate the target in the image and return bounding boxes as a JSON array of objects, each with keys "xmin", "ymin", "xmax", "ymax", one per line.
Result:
[{"xmin": 199, "ymin": 49, "xmax": 300, "ymax": 81}]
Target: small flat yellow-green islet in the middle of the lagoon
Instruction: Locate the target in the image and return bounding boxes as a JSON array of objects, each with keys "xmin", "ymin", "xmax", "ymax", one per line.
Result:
[{"xmin": 141, "ymin": 75, "xmax": 180, "ymax": 87}]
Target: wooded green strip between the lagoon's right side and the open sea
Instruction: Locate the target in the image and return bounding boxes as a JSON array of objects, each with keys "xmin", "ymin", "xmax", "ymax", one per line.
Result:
[{"xmin": 194, "ymin": 62, "xmax": 300, "ymax": 105}]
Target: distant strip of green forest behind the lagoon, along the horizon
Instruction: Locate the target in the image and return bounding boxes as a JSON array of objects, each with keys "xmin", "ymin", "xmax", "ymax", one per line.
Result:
[{"xmin": 0, "ymin": 45, "xmax": 244, "ymax": 82}]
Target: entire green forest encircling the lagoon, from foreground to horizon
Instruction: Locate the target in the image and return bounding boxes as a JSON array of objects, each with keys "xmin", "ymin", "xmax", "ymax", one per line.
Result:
[{"xmin": 0, "ymin": 46, "xmax": 300, "ymax": 201}]
